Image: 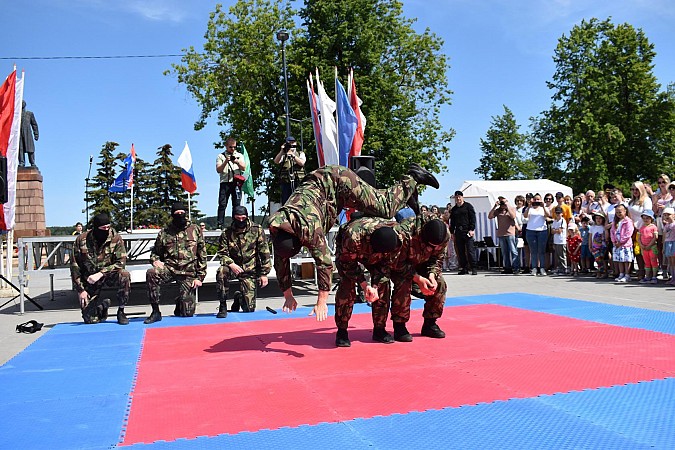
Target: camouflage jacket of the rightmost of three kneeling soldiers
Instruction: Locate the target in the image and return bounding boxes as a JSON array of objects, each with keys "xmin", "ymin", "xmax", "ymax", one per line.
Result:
[{"xmin": 218, "ymin": 220, "xmax": 272, "ymax": 278}]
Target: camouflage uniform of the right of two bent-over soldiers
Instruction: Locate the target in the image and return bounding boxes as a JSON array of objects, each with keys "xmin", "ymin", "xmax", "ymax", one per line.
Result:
[{"xmin": 388, "ymin": 219, "xmax": 450, "ymax": 324}]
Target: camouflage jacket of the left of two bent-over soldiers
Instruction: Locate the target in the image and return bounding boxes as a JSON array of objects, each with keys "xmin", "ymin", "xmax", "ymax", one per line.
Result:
[{"xmin": 335, "ymin": 217, "xmax": 405, "ymax": 284}]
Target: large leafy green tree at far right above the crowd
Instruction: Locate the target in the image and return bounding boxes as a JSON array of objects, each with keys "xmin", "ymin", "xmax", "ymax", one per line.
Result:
[{"xmin": 530, "ymin": 19, "xmax": 675, "ymax": 191}]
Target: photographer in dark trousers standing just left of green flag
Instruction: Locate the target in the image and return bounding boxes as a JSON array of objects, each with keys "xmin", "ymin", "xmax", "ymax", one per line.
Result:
[{"xmin": 216, "ymin": 137, "xmax": 246, "ymax": 229}]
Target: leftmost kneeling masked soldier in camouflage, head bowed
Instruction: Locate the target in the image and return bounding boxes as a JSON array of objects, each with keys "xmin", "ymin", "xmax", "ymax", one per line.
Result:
[{"xmin": 70, "ymin": 214, "xmax": 131, "ymax": 325}]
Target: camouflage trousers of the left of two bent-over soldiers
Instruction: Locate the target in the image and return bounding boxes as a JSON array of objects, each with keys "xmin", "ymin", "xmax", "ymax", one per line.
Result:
[{"xmin": 335, "ymin": 275, "xmax": 391, "ymax": 329}]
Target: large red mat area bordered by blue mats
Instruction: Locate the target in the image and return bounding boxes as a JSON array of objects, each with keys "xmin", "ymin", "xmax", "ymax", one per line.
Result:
[{"xmin": 123, "ymin": 305, "xmax": 675, "ymax": 445}]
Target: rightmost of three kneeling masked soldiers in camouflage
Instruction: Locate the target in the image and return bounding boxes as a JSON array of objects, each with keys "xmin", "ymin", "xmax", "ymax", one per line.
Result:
[{"xmin": 216, "ymin": 206, "xmax": 272, "ymax": 319}]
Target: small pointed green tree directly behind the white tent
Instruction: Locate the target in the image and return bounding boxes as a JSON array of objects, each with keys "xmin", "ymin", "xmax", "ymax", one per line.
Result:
[{"xmin": 475, "ymin": 105, "xmax": 534, "ymax": 180}]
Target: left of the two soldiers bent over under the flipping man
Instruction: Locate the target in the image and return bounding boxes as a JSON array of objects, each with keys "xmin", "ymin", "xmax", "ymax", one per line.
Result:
[{"xmin": 335, "ymin": 217, "xmax": 402, "ymax": 347}]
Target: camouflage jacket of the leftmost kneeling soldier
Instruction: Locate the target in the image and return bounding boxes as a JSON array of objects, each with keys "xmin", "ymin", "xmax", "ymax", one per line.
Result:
[{"xmin": 70, "ymin": 228, "xmax": 127, "ymax": 292}]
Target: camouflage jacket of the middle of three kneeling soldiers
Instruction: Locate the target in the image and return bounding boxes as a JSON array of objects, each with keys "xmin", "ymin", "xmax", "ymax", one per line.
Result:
[{"xmin": 150, "ymin": 223, "xmax": 206, "ymax": 281}]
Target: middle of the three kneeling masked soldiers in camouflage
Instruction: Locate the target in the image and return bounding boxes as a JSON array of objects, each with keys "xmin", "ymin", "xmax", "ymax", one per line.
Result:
[{"xmin": 144, "ymin": 202, "xmax": 206, "ymax": 323}]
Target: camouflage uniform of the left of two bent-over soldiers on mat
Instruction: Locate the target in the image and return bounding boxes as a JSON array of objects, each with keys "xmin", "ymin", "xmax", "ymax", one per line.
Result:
[{"xmin": 335, "ymin": 217, "xmax": 403, "ymax": 329}]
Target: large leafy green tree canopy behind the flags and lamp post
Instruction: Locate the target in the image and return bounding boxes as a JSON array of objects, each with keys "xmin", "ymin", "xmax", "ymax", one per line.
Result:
[{"xmin": 168, "ymin": 0, "xmax": 454, "ymax": 200}]
